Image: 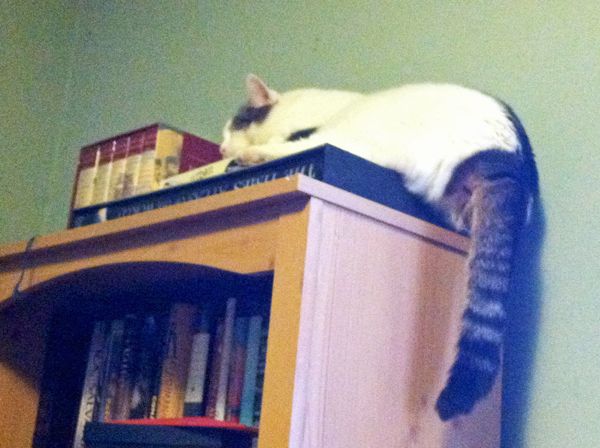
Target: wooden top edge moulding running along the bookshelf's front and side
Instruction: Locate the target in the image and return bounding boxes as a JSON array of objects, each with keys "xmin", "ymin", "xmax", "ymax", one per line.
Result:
[{"xmin": 0, "ymin": 174, "xmax": 468, "ymax": 263}]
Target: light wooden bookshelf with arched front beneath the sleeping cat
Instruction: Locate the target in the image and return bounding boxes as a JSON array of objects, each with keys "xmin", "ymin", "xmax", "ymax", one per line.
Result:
[{"xmin": 0, "ymin": 175, "xmax": 500, "ymax": 448}]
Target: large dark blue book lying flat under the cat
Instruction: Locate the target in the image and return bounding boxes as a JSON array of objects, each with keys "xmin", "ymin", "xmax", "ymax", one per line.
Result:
[{"xmin": 70, "ymin": 145, "xmax": 442, "ymax": 227}]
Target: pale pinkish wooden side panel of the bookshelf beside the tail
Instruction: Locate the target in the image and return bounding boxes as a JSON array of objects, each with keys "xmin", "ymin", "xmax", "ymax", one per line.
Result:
[{"xmin": 289, "ymin": 199, "xmax": 500, "ymax": 448}]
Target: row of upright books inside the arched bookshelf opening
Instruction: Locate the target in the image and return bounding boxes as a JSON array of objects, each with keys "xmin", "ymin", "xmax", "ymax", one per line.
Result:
[{"xmin": 73, "ymin": 298, "xmax": 268, "ymax": 448}]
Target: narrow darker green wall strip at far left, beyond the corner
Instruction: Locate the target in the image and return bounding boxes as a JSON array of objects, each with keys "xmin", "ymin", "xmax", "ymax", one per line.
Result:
[{"xmin": 0, "ymin": 0, "xmax": 74, "ymax": 241}]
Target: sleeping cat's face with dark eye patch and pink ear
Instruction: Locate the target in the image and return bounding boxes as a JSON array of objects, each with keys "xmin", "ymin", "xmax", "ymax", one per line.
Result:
[{"xmin": 221, "ymin": 75, "xmax": 289, "ymax": 158}]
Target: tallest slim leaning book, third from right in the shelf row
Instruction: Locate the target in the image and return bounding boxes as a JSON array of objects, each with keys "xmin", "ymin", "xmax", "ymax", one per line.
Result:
[{"xmin": 206, "ymin": 298, "xmax": 237, "ymax": 420}]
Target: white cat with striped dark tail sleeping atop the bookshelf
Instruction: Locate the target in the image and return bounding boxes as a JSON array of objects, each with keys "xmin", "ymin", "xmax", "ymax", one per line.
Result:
[{"xmin": 221, "ymin": 75, "xmax": 538, "ymax": 421}]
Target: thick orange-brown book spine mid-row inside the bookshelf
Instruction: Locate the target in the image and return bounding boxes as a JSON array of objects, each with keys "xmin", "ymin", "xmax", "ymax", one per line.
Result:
[{"xmin": 157, "ymin": 303, "xmax": 197, "ymax": 418}]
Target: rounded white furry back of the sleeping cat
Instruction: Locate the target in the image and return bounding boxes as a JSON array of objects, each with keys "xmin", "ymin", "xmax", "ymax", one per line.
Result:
[{"xmin": 324, "ymin": 83, "xmax": 519, "ymax": 156}]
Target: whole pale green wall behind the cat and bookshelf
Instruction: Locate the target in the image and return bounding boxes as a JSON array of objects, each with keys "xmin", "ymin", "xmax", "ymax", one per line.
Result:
[{"xmin": 0, "ymin": 0, "xmax": 600, "ymax": 448}]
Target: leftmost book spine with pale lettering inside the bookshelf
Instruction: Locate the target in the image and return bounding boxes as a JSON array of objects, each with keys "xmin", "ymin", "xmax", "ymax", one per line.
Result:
[{"xmin": 73, "ymin": 321, "xmax": 107, "ymax": 448}]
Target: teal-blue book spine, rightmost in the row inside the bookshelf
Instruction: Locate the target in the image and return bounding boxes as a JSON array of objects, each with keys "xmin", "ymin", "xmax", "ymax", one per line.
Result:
[{"xmin": 240, "ymin": 316, "xmax": 263, "ymax": 426}]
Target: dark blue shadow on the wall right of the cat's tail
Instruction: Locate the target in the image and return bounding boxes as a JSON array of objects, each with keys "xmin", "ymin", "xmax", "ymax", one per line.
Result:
[{"xmin": 502, "ymin": 200, "xmax": 546, "ymax": 448}]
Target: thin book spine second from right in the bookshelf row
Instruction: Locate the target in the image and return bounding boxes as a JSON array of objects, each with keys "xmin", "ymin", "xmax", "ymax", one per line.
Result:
[{"xmin": 225, "ymin": 317, "xmax": 248, "ymax": 423}]
